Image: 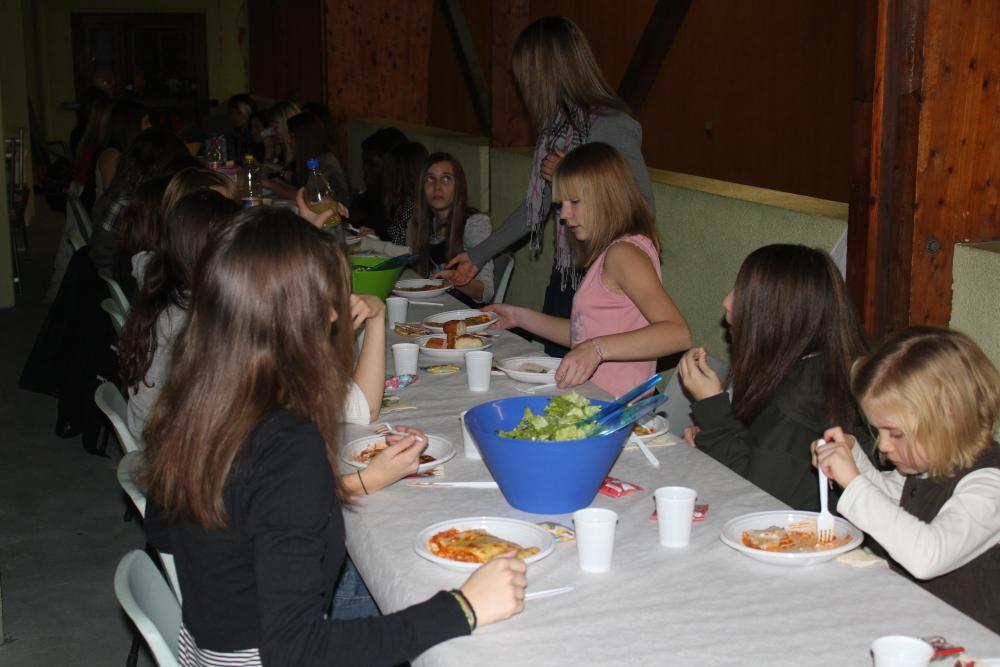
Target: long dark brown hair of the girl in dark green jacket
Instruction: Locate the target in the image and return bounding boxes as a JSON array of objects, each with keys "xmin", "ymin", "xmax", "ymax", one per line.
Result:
[{"xmin": 729, "ymin": 244, "xmax": 869, "ymax": 428}]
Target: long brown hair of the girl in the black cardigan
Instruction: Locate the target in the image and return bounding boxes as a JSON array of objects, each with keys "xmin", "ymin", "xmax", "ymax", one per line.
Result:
[{"xmin": 143, "ymin": 207, "xmax": 354, "ymax": 528}]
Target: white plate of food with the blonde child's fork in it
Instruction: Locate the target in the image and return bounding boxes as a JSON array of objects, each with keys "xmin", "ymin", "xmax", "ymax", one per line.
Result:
[{"xmin": 719, "ymin": 510, "xmax": 864, "ymax": 567}]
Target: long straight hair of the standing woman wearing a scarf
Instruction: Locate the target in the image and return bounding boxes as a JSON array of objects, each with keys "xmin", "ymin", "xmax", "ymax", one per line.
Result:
[{"xmin": 511, "ymin": 16, "xmax": 629, "ymax": 131}]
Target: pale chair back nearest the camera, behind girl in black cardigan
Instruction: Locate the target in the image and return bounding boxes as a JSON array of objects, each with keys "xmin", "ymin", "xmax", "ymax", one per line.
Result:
[{"xmin": 115, "ymin": 549, "xmax": 181, "ymax": 667}]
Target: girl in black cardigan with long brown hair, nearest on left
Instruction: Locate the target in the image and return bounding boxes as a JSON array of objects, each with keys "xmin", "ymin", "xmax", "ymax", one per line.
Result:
[{"xmin": 146, "ymin": 208, "xmax": 527, "ymax": 665}]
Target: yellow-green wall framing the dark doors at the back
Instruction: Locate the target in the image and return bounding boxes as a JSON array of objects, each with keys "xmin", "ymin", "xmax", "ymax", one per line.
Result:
[{"xmin": 35, "ymin": 0, "xmax": 249, "ymax": 139}]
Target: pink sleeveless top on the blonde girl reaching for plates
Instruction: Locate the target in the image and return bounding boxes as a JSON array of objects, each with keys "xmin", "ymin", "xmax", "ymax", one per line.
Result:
[{"xmin": 570, "ymin": 235, "xmax": 663, "ymax": 396}]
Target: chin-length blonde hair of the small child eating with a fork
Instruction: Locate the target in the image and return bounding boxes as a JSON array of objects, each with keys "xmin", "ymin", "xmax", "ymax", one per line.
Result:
[{"xmin": 852, "ymin": 326, "xmax": 1000, "ymax": 477}]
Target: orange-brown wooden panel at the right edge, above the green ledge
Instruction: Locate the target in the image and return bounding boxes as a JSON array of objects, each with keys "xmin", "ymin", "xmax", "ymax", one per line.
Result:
[{"xmin": 910, "ymin": 0, "xmax": 1000, "ymax": 324}]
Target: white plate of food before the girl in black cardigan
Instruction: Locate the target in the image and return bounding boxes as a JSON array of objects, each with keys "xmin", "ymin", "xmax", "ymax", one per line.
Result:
[{"xmin": 413, "ymin": 516, "xmax": 556, "ymax": 572}]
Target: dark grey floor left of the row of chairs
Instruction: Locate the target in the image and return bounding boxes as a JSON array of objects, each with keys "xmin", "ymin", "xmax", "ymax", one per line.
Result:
[{"xmin": 0, "ymin": 203, "xmax": 153, "ymax": 667}]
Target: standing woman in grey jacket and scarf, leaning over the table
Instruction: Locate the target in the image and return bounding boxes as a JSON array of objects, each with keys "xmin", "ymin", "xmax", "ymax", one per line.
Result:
[{"xmin": 448, "ymin": 16, "xmax": 655, "ymax": 356}]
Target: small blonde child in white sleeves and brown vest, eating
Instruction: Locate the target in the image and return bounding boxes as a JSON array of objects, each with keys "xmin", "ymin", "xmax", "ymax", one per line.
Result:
[{"xmin": 813, "ymin": 327, "xmax": 1000, "ymax": 632}]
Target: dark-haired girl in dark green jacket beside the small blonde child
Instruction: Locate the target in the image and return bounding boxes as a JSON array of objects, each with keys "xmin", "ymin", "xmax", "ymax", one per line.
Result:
[{"xmin": 677, "ymin": 244, "xmax": 871, "ymax": 510}]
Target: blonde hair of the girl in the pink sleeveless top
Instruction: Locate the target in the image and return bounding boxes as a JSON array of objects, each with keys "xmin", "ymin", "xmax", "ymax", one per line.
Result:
[{"xmin": 552, "ymin": 141, "xmax": 660, "ymax": 266}]
